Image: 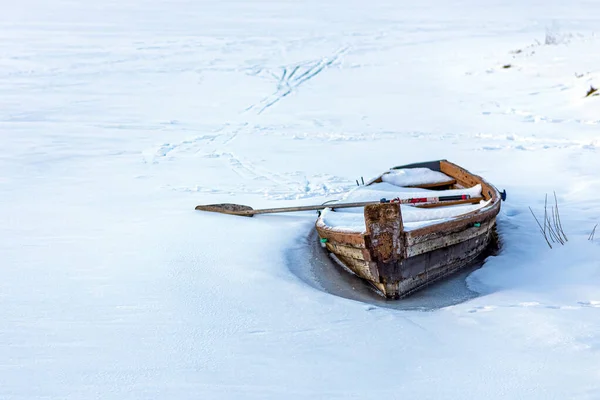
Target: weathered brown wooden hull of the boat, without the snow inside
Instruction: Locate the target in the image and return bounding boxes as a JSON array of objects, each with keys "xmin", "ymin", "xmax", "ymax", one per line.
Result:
[{"xmin": 316, "ymin": 160, "xmax": 500, "ymax": 299}]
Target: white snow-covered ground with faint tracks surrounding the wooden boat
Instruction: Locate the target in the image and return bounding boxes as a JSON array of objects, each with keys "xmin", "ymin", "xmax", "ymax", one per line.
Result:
[{"xmin": 0, "ymin": 0, "xmax": 600, "ymax": 399}]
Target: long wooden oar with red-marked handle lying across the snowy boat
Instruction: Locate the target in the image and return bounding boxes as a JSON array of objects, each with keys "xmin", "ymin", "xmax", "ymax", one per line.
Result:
[{"xmin": 196, "ymin": 195, "xmax": 482, "ymax": 217}]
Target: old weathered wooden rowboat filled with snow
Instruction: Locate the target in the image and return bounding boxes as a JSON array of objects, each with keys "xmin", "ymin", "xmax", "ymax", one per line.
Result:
[{"xmin": 316, "ymin": 160, "xmax": 506, "ymax": 299}]
